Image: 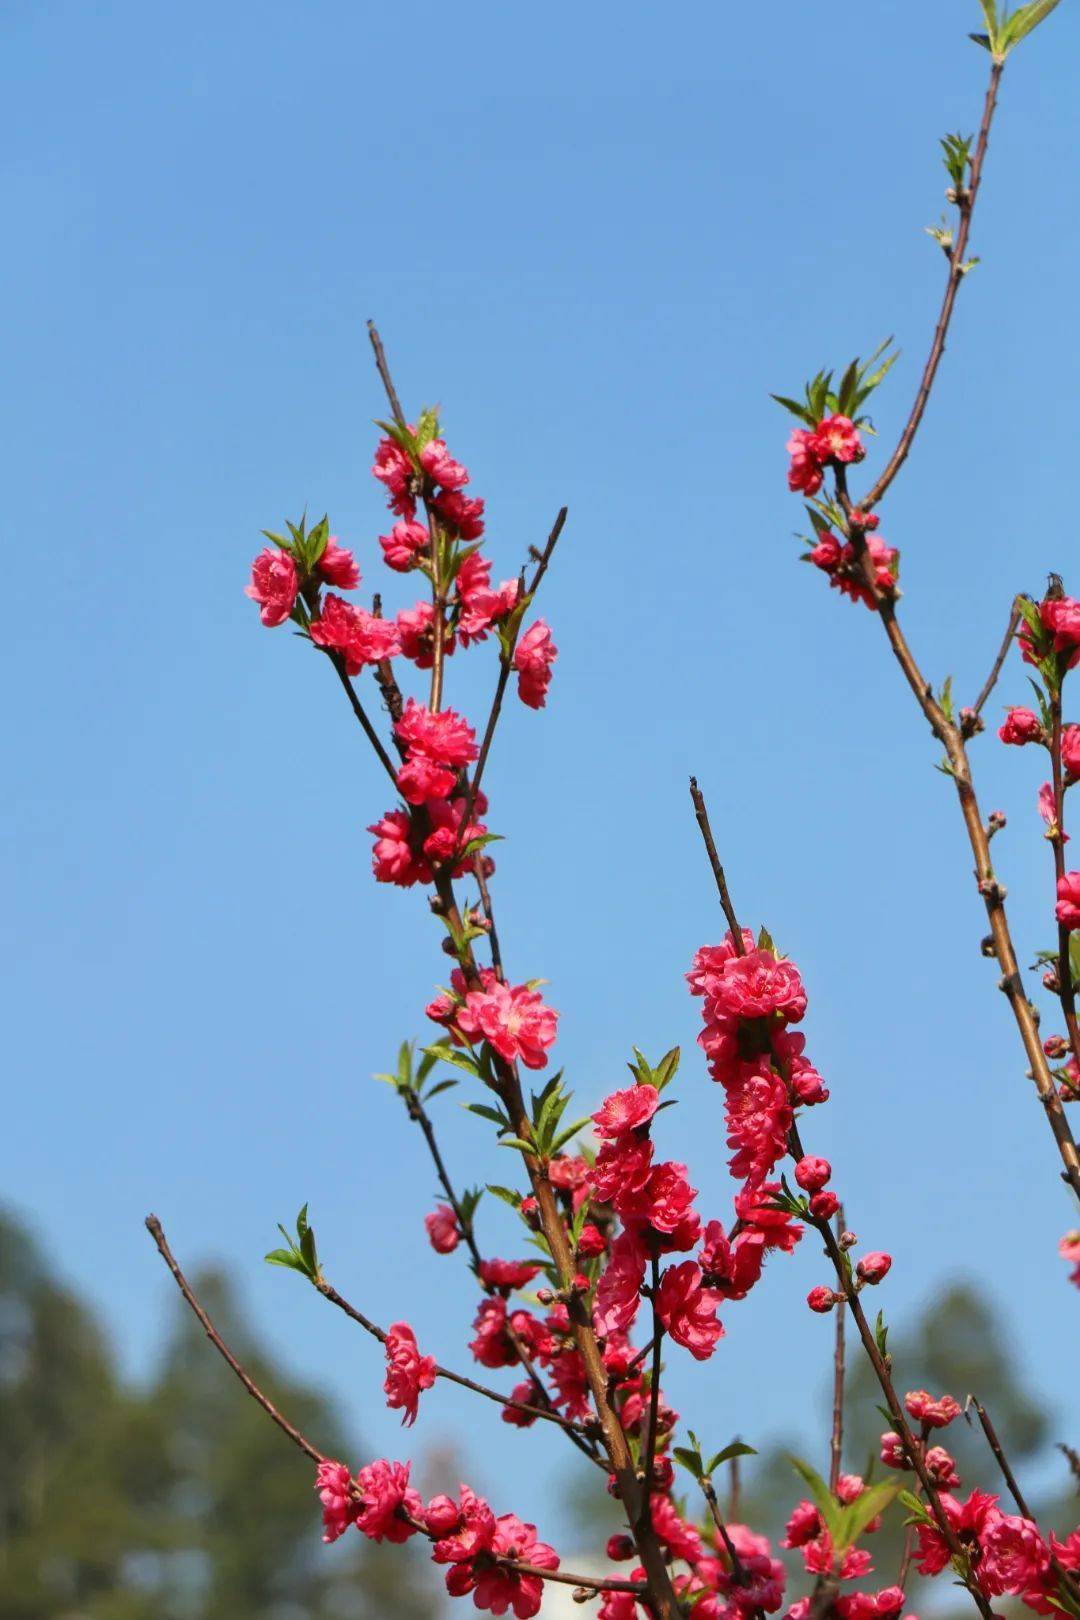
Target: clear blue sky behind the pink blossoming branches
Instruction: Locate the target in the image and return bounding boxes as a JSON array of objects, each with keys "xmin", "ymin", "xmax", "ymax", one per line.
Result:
[{"xmin": 0, "ymin": 0, "xmax": 1080, "ymax": 1542}]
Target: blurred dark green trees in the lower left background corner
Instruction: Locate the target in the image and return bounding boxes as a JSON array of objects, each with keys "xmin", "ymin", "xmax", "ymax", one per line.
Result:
[{"xmin": 0, "ymin": 1215, "xmax": 437, "ymax": 1620}]
